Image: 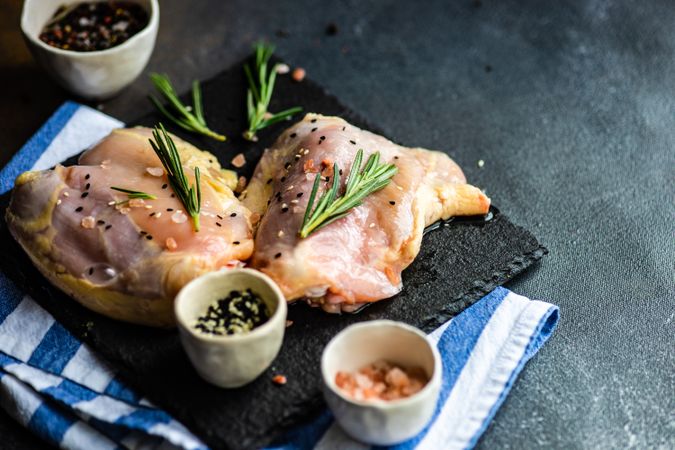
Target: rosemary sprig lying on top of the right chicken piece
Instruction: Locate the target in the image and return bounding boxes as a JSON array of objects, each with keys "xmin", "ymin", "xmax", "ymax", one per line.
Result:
[{"xmin": 298, "ymin": 149, "xmax": 398, "ymax": 238}]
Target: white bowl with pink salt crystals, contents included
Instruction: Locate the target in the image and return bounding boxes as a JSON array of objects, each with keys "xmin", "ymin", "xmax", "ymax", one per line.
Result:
[{"xmin": 321, "ymin": 320, "xmax": 443, "ymax": 445}]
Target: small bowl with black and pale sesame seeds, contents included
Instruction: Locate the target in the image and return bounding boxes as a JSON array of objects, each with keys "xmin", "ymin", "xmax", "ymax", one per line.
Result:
[{"xmin": 174, "ymin": 269, "xmax": 287, "ymax": 388}]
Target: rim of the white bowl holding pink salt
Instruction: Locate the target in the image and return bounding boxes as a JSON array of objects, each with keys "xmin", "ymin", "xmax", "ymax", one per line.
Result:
[{"xmin": 321, "ymin": 319, "xmax": 443, "ymax": 410}]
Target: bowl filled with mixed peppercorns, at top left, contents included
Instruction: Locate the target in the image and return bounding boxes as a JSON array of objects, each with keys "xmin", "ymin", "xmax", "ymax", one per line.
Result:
[{"xmin": 21, "ymin": 0, "xmax": 159, "ymax": 100}]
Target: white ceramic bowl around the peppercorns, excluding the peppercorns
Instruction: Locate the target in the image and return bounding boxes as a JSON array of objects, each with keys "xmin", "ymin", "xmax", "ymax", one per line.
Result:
[{"xmin": 21, "ymin": 0, "xmax": 159, "ymax": 100}]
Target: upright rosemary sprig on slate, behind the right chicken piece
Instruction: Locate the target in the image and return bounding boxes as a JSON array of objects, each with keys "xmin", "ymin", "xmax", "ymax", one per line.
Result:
[{"xmin": 244, "ymin": 42, "xmax": 302, "ymax": 141}]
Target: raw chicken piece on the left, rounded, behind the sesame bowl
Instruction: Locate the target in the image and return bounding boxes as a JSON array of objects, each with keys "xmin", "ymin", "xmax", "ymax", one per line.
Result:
[{"xmin": 6, "ymin": 128, "xmax": 253, "ymax": 326}]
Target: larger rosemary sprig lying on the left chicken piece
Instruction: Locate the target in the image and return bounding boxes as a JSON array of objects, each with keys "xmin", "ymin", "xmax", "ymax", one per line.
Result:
[{"xmin": 150, "ymin": 123, "xmax": 202, "ymax": 231}]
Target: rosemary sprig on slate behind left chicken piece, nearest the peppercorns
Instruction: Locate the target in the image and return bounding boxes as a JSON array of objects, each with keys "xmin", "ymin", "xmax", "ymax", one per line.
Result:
[{"xmin": 149, "ymin": 73, "xmax": 227, "ymax": 142}]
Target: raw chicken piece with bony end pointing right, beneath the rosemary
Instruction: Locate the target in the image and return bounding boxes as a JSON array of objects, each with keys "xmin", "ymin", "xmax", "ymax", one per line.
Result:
[{"xmin": 242, "ymin": 114, "xmax": 490, "ymax": 312}]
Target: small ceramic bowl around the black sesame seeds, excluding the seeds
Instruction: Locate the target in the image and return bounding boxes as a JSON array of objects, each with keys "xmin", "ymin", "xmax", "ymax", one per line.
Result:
[{"xmin": 174, "ymin": 269, "xmax": 287, "ymax": 388}]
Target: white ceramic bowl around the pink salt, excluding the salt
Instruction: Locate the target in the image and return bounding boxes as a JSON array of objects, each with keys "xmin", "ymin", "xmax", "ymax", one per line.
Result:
[{"xmin": 321, "ymin": 320, "xmax": 443, "ymax": 445}]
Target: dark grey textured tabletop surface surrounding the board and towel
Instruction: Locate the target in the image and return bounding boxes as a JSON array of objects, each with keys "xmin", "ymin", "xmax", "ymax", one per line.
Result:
[{"xmin": 0, "ymin": 0, "xmax": 675, "ymax": 448}]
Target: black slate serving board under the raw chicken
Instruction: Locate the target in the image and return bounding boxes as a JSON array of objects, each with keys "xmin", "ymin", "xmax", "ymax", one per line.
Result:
[{"xmin": 0, "ymin": 59, "xmax": 546, "ymax": 448}]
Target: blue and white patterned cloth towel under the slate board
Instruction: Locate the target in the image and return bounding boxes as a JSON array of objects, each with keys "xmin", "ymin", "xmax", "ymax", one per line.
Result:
[{"xmin": 0, "ymin": 102, "xmax": 558, "ymax": 450}]
